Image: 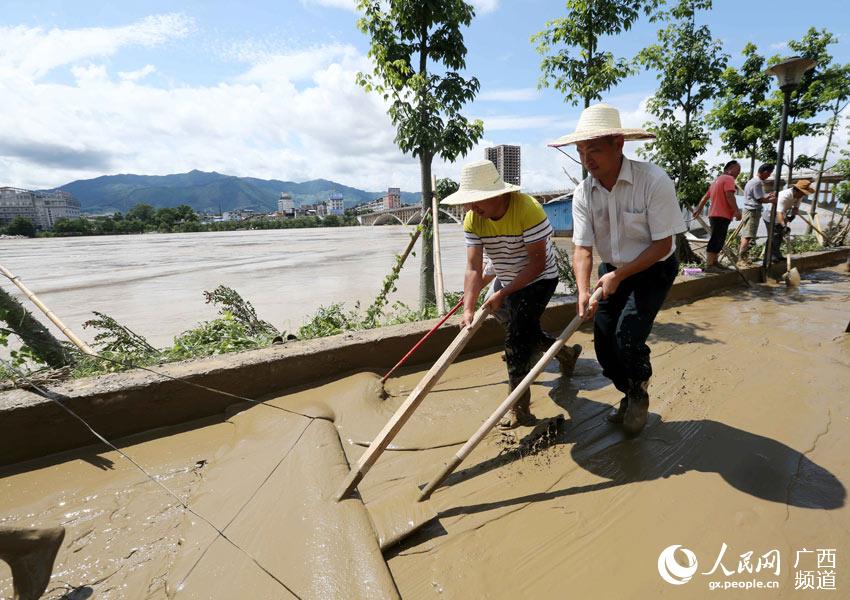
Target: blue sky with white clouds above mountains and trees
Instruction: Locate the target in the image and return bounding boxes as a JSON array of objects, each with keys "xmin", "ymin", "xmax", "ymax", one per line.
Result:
[{"xmin": 0, "ymin": 0, "xmax": 850, "ymax": 190}]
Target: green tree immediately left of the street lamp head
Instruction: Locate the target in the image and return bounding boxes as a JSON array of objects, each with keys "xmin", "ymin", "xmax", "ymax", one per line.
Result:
[{"xmin": 706, "ymin": 43, "xmax": 777, "ymax": 179}]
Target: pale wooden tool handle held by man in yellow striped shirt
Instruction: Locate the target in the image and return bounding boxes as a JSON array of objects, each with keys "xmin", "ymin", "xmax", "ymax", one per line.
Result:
[{"xmin": 336, "ymin": 307, "xmax": 490, "ymax": 500}]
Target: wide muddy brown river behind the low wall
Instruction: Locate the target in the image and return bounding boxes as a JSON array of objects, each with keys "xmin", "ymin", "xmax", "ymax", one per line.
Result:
[{"xmin": 0, "ymin": 224, "xmax": 465, "ymax": 347}]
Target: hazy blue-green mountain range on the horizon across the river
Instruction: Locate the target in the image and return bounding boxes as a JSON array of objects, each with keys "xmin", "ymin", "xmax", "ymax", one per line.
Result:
[{"xmin": 59, "ymin": 170, "xmax": 420, "ymax": 214}]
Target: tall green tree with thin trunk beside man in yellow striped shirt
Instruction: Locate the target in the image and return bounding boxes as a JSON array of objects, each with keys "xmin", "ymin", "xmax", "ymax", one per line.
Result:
[{"xmin": 357, "ymin": 0, "xmax": 484, "ymax": 309}]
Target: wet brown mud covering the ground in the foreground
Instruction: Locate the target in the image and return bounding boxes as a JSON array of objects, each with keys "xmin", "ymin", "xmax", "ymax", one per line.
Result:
[{"xmin": 0, "ymin": 269, "xmax": 850, "ymax": 598}]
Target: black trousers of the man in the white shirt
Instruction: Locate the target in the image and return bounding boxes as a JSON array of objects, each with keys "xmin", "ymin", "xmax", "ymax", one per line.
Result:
[{"xmin": 593, "ymin": 255, "xmax": 679, "ymax": 393}]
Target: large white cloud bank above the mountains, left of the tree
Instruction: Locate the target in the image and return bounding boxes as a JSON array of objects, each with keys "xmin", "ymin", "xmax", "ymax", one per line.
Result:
[{"xmin": 0, "ymin": 19, "xmax": 419, "ymax": 190}]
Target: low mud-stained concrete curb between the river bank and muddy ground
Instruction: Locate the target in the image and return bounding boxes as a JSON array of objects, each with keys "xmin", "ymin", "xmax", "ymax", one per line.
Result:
[{"xmin": 0, "ymin": 248, "xmax": 848, "ymax": 466}]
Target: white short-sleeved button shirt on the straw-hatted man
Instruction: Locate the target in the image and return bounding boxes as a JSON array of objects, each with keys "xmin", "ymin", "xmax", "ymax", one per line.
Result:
[{"xmin": 573, "ymin": 157, "xmax": 686, "ymax": 267}]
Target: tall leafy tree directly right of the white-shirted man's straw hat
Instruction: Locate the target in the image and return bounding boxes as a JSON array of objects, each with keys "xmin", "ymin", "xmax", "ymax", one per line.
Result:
[{"xmin": 638, "ymin": 0, "xmax": 726, "ymax": 206}]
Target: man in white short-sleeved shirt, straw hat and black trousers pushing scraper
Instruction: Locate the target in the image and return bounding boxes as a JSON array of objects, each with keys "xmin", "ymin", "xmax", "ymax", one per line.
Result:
[{"xmin": 550, "ymin": 104, "xmax": 685, "ymax": 434}]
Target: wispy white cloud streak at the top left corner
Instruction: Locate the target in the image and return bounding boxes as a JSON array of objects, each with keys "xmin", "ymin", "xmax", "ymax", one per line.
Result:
[{"xmin": 0, "ymin": 14, "xmax": 194, "ymax": 79}]
